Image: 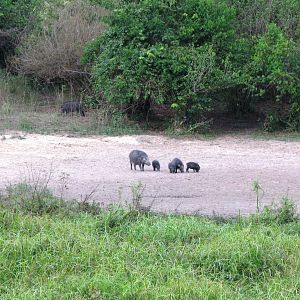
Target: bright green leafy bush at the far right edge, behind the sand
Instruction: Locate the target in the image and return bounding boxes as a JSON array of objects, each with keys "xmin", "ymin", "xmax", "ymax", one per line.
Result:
[{"xmin": 248, "ymin": 24, "xmax": 300, "ymax": 131}]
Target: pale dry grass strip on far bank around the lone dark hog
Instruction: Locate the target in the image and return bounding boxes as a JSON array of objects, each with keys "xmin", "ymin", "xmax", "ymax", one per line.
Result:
[{"xmin": 0, "ymin": 70, "xmax": 142, "ymax": 135}]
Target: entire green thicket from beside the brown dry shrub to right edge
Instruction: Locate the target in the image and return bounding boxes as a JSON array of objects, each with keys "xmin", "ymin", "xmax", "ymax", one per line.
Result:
[{"xmin": 83, "ymin": 0, "xmax": 300, "ymax": 130}]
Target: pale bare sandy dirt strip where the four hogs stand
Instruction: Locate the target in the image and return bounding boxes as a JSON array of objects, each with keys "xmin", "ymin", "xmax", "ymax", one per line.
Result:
[{"xmin": 0, "ymin": 134, "xmax": 300, "ymax": 215}]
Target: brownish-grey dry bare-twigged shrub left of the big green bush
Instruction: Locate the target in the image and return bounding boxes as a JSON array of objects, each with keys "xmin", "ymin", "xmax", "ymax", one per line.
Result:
[{"xmin": 16, "ymin": 1, "xmax": 107, "ymax": 86}]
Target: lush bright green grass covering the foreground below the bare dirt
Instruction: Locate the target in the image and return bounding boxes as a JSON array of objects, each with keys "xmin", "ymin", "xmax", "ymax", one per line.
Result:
[{"xmin": 0, "ymin": 185, "xmax": 300, "ymax": 300}]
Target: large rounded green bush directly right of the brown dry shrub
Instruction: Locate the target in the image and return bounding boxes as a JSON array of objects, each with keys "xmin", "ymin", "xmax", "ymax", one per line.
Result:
[{"xmin": 84, "ymin": 0, "xmax": 234, "ymax": 119}]
